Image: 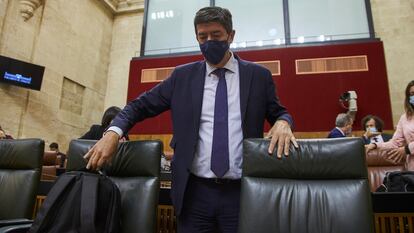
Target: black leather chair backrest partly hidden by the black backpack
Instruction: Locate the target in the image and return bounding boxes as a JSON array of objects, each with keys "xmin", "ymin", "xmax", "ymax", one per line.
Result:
[{"xmin": 67, "ymin": 140, "xmax": 163, "ymax": 233}]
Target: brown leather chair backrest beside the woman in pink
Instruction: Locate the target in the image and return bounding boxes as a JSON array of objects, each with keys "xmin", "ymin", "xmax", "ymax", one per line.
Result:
[{"xmin": 366, "ymin": 150, "xmax": 405, "ymax": 192}]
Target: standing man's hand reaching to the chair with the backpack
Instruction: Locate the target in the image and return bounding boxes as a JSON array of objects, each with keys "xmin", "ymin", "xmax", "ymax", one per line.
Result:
[{"xmin": 83, "ymin": 131, "xmax": 119, "ymax": 170}]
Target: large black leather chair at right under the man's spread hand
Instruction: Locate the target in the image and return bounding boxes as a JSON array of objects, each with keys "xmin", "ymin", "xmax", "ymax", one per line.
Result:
[{"xmin": 239, "ymin": 138, "xmax": 374, "ymax": 233}]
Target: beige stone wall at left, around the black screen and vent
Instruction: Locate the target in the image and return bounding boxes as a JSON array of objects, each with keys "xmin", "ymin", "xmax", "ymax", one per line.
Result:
[{"xmin": 0, "ymin": 0, "xmax": 113, "ymax": 150}]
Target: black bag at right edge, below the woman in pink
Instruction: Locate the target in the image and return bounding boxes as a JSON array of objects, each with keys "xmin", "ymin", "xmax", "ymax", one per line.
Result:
[{"xmin": 375, "ymin": 171, "xmax": 414, "ymax": 192}]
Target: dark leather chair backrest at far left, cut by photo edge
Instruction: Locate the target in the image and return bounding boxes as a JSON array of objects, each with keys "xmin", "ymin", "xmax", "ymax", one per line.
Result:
[{"xmin": 0, "ymin": 139, "xmax": 45, "ymax": 220}]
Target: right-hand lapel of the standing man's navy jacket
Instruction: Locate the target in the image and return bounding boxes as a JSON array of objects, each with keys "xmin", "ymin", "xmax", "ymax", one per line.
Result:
[{"xmin": 236, "ymin": 56, "xmax": 252, "ymax": 125}]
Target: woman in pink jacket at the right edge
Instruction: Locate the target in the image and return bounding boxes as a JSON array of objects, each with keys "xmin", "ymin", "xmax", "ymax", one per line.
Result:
[{"xmin": 366, "ymin": 80, "xmax": 414, "ymax": 170}]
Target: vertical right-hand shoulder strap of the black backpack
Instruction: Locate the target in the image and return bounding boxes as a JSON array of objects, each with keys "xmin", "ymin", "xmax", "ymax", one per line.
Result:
[{"xmin": 80, "ymin": 175, "xmax": 99, "ymax": 233}]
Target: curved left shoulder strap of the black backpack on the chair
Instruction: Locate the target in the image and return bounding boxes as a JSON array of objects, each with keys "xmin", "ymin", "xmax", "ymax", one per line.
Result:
[{"xmin": 29, "ymin": 174, "xmax": 76, "ymax": 233}]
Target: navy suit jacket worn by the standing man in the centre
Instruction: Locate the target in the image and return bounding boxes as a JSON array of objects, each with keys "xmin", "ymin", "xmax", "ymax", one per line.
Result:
[{"xmin": 111, "ymin": 57, "xmax": 292, "ymax": 215}]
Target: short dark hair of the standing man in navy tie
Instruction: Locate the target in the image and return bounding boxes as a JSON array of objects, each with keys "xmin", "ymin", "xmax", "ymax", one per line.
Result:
[{"xmin": 194, "ymin": 6, "xmax": 233, "ymax": 34}]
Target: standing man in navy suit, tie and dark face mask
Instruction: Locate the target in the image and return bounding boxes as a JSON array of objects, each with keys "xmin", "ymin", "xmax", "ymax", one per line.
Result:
[{"xmin": 85, "ymin": 7, "xmax": 298, "ymax": 233}]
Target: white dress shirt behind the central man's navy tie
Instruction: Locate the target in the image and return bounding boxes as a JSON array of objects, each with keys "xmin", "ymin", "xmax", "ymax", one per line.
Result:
[{"xmin": 191, "ymin": 54, "xmax": 243, "ymax": 179}]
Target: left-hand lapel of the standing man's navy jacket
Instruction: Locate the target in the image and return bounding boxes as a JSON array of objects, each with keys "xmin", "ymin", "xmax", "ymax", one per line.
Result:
[{"xmin": 191, "ymin": 62, "xmax": 206, "ymax": 135}]
